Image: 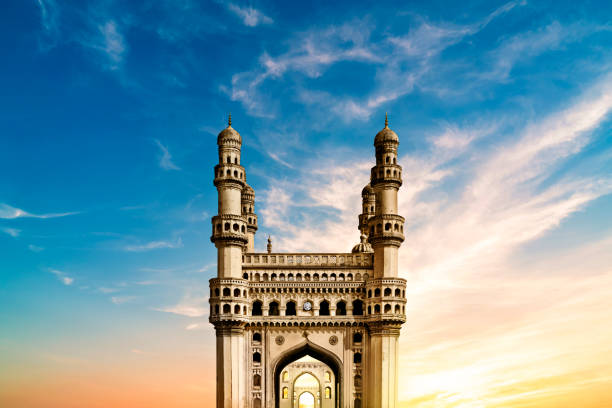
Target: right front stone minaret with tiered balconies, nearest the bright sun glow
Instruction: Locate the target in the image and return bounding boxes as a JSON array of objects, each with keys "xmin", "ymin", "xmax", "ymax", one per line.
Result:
[{"xmin": 366, "ymin": 115, "xmax": 405, "ymax": 408}]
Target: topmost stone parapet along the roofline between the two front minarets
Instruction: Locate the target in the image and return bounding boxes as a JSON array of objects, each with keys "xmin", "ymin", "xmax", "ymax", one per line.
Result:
[{"xmin": 242, "ymin": 253, "xmax": 374, "ymax": 269}]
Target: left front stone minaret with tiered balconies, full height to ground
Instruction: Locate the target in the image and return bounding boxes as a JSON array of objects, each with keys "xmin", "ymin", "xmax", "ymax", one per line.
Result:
[{"xmin": 209, "ymin": 115, "xmax": 248, "ymax": 408}]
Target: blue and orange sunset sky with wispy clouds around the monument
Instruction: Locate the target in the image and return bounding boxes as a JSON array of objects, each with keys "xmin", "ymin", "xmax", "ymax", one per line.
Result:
[{"xmin": 0, "ymin": 0, "xmax": 612, "ymax": 408}]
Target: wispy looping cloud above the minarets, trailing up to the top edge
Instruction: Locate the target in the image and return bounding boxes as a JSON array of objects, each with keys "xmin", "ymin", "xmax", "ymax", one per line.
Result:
[{"xmin": 227, "ymin": 1, "xmax": 524, "ymax": 121}]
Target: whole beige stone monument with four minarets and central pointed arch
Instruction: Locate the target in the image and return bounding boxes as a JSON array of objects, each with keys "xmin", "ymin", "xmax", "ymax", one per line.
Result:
[{"xmin": 210, "ymin": 116, "xmax": 406, "ymax": 408}]
